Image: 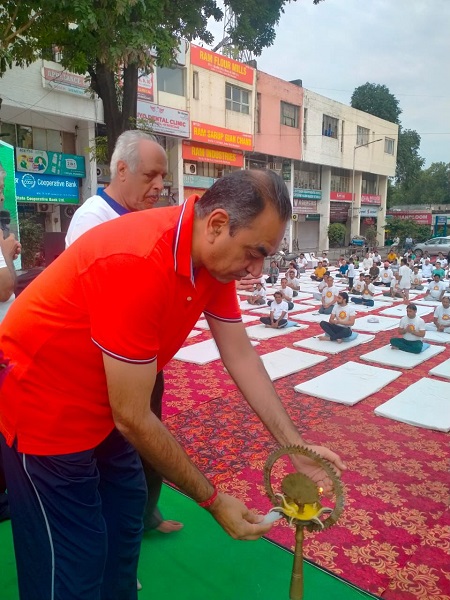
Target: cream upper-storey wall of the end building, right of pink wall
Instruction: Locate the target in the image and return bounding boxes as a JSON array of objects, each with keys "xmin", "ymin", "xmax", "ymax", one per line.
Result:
[{"xmin": 303, "ymin": 90, "xmax": 398, "ymax": 177}]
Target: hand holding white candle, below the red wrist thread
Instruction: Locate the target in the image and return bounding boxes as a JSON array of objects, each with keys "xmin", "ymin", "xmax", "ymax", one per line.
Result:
[{"xmin": 208, "ymin": 494, "xmax": 272, "ymax": 540}]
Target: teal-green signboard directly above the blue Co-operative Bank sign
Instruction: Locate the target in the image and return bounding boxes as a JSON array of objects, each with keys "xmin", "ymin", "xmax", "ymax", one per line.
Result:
[{"xmin": 16, "ymin": 148, "xmax": 86, "ymax": 178}]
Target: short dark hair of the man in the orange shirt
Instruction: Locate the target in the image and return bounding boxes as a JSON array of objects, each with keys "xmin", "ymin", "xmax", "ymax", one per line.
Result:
[{"xmin": 195, "ymin": 169, "xmax": 292, "ymax": 235}]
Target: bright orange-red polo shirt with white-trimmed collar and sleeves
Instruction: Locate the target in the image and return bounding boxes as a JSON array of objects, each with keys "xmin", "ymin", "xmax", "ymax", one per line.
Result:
[{"xmin": 0, "ymin": 196, "xmax": 241, "ymax": 455}]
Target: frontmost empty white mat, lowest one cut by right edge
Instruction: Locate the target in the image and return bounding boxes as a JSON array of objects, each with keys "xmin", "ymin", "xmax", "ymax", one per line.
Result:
[{"xmin": 375, "ymin": 377, "xmax": 450, "ymax": 432}]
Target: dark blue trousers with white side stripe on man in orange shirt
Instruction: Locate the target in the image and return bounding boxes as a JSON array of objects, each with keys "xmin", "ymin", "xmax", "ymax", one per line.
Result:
[{"xmin": 0, "ymin": 430, "xmax": 147, "ymax": 600}]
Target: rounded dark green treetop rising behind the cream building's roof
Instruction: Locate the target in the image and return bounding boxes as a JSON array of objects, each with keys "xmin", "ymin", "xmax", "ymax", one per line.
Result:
[{"xmin": 350, "ymin": 82, "xmax": 402, "ymax": 124}]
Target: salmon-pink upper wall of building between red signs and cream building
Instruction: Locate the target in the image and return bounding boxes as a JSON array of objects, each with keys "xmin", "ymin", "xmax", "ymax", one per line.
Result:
[{"xmin": 255, "ymin": 71, "xmax": 303, "ymax": 160}]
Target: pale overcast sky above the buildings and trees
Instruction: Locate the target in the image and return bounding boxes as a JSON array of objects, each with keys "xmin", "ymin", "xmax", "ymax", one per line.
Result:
[{"xmin": 206, "ymin": 0, "xmax": 450, "ymax": 167}]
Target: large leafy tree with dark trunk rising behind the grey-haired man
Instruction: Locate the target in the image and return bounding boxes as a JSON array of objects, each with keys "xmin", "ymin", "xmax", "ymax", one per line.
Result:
[{"xmin": 0, "ymin": 0, "xmax": 321, "ymax": 159}]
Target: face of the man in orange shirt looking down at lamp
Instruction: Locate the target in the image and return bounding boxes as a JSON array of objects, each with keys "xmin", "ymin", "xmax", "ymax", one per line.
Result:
[{"xmin": 200, "ymin": 205, "xmax": 286, "ymax": 287}]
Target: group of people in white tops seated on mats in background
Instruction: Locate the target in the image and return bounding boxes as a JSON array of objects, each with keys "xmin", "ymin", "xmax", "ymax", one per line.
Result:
[{"xmin": 244, "ymin": 251, "xmax": 450, "ymax": 353}]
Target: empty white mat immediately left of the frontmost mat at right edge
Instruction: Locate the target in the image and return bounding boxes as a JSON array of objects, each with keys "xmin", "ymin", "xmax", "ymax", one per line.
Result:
[{"xmin": 294, "ymin": 361, "xmax": 402, "ymax": 406}]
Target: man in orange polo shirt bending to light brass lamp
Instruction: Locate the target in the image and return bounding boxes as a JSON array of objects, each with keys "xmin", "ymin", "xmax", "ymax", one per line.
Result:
[{"xmin": 0, "ymin": 171, "xmax": 344, "ymax": 600}]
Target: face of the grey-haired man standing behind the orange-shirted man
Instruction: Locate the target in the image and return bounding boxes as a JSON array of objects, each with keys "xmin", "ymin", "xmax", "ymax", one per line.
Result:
[{"xmin": 117, "ymin": 140, "xmax": 167, "ymax": 211}]
